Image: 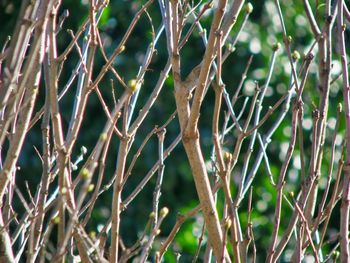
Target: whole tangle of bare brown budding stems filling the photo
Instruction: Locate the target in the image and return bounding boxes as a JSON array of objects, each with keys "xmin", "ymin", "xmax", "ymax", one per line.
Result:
[{"xmin": 0, "ymin": 0, "xmax": 350, "ymax": 263}]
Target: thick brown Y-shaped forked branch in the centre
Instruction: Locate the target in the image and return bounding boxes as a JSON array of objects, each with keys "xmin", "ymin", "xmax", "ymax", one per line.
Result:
[{"xmin": 169, "ymin": 0, "xmax": 230, "ymax": 262}]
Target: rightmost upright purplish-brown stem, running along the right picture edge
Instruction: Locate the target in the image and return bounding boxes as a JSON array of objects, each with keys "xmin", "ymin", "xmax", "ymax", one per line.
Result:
[{"xmin": 337, "ymin": 0, "xmax": 350, "ymax": 262}]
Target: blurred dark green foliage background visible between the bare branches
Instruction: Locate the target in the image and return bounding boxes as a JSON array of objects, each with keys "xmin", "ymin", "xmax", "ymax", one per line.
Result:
[{"xmin": 0, "ymin": 0, "xmax": 344, "ymax": 262}]
